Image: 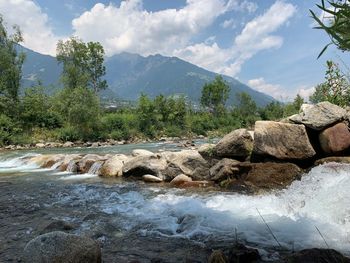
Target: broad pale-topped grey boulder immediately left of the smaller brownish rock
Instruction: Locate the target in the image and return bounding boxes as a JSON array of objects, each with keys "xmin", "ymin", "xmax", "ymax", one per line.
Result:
[{"xmin": 162, "ymin": 150, "xmax": 209, "ymax": 181}]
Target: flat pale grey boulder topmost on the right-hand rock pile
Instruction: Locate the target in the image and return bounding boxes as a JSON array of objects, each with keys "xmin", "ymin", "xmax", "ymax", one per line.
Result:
[{"xmin": 289, "ymin": 101, "xmax": 346, "ymax": 130}]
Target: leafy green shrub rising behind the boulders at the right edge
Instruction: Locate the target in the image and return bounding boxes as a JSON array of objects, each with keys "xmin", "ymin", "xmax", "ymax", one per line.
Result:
[{"xmin": 310, "ymin": 61, "xmax": 350, "ymax": 107}]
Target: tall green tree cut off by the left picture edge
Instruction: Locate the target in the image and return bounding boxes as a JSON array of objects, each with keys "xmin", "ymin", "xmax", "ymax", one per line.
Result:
[{"xmin": 0, "ymin": 15, "xmax": 25, "ymax": 116}]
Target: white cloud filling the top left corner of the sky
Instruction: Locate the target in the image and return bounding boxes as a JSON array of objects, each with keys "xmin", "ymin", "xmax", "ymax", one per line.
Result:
[{"xmin": 0, "ymin": 0, "xmax": 60, "ymax": 55}]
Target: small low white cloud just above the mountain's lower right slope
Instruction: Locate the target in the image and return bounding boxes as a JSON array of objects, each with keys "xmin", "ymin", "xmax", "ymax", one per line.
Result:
[{"xmin": 248, "ymin": 78, "xmax": 288, "ymax": 101}]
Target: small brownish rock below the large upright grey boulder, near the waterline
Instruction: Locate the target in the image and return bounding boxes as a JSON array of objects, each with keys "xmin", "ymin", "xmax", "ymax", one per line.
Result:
[{"xmin": 209, "ymin": 158, "xmax": 240, "ymax": 182}]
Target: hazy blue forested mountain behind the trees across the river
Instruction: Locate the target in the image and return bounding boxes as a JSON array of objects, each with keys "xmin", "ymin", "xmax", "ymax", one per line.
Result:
[{"xmin": 21, "ymin": 47, "xmax": 274, "ymax": 106}]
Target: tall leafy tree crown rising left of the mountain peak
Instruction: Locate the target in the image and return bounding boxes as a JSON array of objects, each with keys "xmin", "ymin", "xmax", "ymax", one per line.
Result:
[{"xmin": 57, "ymin": 37, "xmax": 107, "ymax": 93}]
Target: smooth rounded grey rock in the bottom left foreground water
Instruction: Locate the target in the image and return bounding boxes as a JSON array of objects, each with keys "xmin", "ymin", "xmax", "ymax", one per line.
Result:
[{"xmin": 23, "ymin": 231, "xmax": 102, "ymax": 263}]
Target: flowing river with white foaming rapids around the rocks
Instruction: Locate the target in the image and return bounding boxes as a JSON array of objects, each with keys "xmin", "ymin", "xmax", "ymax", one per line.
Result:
[{"xmin": 0, "ymin": 144, "xmax": 350, "ymax": 262}]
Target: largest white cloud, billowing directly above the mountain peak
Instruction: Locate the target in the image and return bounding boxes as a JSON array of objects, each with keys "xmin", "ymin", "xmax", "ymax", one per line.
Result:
[{"xmin": 72, "ymin": 0, "xmax": 226, "ymax": 55}]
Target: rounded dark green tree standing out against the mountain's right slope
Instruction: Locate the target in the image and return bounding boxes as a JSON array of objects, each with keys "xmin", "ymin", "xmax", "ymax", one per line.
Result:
[{"xmin": 201, "ymin": 76, "xmax": 230, "ymax": 116}]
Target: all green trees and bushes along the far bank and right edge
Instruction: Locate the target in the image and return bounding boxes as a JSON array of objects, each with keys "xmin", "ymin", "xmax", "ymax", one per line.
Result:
[{"xmin": 0, "ymin": 2, "xmax": 350, "ymax": 146}]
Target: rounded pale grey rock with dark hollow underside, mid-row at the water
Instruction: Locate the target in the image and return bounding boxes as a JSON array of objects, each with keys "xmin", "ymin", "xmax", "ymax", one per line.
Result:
[{"xmin": 123, "ymin": 154, "xmax": 167, "ymax": 179}]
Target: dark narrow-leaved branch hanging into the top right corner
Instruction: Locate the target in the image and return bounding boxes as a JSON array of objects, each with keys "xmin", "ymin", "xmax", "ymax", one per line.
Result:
[{"xmin": 310, "ymin": 0, "xmax": 350, "ymax": 57}]
